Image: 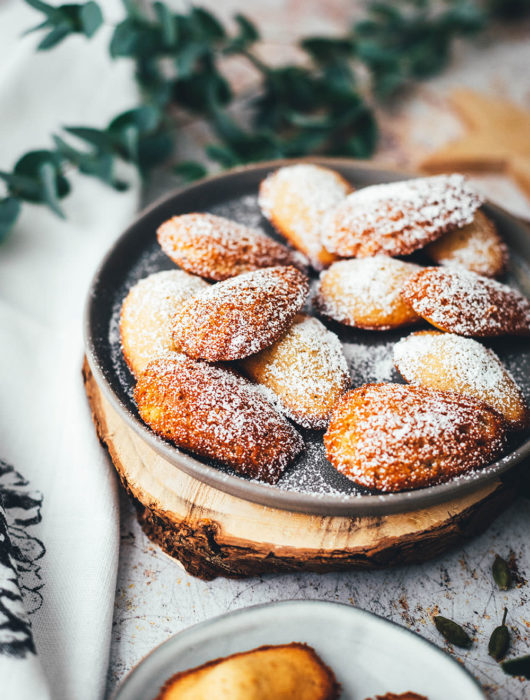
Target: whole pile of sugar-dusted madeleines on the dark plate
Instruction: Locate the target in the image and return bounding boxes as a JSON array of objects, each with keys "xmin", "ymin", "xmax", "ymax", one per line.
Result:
[{"xmin": 120, "ymin": 164, "xmax": 530, "ymax": 492}]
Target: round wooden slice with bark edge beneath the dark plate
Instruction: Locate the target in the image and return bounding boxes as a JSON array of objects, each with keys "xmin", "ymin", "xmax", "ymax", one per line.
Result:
[{"xmin": 83, "ymin": 360, "xmax": 516, "ymax": 580}]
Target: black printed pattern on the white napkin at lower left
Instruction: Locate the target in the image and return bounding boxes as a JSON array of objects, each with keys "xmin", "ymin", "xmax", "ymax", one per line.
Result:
[{"xmin": 0, "ymin": 460, "xmax": 46, "ymax": 658}]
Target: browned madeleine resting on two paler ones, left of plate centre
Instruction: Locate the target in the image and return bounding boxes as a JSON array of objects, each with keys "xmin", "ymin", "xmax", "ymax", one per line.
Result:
[{"xmin": 169, "ymin": 267, "xmax": 309, "ymax": 362}]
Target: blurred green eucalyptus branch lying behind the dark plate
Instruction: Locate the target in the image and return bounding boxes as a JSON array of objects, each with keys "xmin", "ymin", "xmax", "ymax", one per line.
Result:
[{"xmin": 0, "ymin": 0, "xmax": 530, "ymax": 240}]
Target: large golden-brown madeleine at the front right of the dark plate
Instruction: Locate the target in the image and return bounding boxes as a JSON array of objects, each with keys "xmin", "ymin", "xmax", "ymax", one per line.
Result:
[{"xmin": 324, "ymin": 384, "xmax": 506, "ymax": 492}]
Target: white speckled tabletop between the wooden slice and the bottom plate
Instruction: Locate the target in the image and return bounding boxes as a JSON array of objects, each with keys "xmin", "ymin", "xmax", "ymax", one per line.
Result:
[{"xmin": 108, "ymin": 492, "xmax": 530, "ymax": 700}]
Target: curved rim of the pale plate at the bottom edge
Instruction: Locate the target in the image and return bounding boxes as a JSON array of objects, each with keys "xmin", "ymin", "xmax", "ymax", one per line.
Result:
[{"xmin": 109, "ymin": 598, "xmax": 488, "ymax": 700}]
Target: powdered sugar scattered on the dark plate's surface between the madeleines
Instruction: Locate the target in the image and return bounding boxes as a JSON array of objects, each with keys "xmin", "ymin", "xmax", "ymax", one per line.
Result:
[{"xmin": 102, "ymin": 178, "xmax": 530, "ymax": 502}]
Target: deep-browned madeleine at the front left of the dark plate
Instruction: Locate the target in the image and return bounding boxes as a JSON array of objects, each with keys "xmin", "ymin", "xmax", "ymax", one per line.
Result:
[{"xmin": 134, "ymin": 353, "xmax": 303, "ymax": 484}]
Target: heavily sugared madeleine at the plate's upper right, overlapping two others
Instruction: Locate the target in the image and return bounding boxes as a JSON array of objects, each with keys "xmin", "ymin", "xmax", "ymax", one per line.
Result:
[{"xmin": 323, "ymin": 174, "xmax": 483, "ymax": 257}]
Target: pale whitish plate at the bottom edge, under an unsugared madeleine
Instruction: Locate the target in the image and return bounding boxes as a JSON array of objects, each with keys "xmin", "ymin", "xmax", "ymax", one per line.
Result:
[{"xmin": 114, "ymin": 600, "xmax": 486, "ymax": 700}]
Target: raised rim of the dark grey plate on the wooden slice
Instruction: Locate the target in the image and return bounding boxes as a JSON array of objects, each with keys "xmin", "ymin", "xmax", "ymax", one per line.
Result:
[{"xmin": 83, "ymin": 158, "xmax": 530, "ymax": 516}]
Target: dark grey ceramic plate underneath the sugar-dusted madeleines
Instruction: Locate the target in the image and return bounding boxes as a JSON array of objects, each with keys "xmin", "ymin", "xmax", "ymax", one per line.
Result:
[{"xmin": 85, "ymin": 159, "xmax": 530, "ymax": 515}]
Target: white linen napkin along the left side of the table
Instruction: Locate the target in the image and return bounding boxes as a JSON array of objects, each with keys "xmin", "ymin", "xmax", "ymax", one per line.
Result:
[{"xmin": 0, "ymin": 0, "xmax": 139, "ymax": 700}]
